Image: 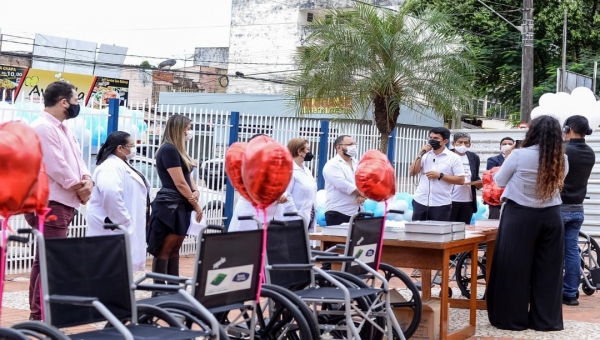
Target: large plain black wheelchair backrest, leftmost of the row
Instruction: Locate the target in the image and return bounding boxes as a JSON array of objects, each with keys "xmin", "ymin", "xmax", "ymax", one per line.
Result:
[{"xmin": 40, "ymin": 234, "xmax": 135, "ymax": 328}]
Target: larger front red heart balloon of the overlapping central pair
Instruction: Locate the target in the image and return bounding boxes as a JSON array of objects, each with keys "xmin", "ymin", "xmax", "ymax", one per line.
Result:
[{"xmin": 242, "ymin": 136, "xmax": 294, "ymax": 209}]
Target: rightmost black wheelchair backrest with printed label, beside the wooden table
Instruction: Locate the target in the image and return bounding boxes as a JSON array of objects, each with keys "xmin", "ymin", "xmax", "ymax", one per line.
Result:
[{"xmin": 342, "ymin": 215, "xmax": 383, "ymax": 275}]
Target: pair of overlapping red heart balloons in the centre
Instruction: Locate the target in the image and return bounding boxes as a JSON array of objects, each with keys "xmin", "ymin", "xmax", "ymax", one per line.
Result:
[{"xmin": 225, "ymin": 136, "xmax": 293, "ymax": 209}]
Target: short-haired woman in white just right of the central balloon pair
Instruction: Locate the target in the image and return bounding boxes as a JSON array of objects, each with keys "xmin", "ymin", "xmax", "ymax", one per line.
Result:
[{"xmin": 286, "ymin": 138, "xmax": 317, "ymax": 231}]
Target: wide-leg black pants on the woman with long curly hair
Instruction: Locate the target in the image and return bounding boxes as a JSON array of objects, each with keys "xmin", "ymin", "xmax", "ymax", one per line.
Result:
[{"xmin": 487, "ymin": 200, "xmax": 564, "ymax": 331}]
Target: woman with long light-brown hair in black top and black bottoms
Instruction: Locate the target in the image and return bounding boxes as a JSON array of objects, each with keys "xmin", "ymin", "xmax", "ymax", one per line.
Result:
[{"xmin": 147, "ymin": 115, "xmax": 202, "ymax": 283}]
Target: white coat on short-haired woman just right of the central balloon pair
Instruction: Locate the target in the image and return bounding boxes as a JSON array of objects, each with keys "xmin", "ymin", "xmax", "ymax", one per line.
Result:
[{"xmin": 286, "ymin": 162, "xmax": 317, "ymax": 230}]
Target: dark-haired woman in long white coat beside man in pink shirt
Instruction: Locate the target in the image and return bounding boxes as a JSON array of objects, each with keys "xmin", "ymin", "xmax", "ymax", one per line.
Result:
[{"xmin": 87, "ymin": 131, "xmax": 150, "ymax": 271}]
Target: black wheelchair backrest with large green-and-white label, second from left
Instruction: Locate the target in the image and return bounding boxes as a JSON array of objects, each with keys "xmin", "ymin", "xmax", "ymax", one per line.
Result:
[{"xmin": 194, "ymin": 229, "xmax": 263, "ymax": 308}]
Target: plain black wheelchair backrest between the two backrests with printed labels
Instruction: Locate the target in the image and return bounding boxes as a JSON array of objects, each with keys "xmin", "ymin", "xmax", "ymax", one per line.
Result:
[{"xmin": 267, "ymin": 219, "xmax": 312, "ymax": 289}]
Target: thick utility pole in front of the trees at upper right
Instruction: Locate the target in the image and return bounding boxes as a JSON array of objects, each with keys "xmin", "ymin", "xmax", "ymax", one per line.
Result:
[{"xmin": 521, "ymin": 0, "xmax": 533, "ymax": 123}]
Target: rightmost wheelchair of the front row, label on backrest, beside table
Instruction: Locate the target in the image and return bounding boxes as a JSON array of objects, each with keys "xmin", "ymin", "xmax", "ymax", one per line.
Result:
[{"xmin": 316, "ymin": 210, "xmax": 422, "ymax": 339}]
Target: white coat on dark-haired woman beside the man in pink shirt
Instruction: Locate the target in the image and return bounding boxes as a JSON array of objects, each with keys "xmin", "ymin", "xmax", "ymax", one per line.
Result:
[{"xmin": 87, "ymin": 155, "xmax": 149, "ymax": 271}]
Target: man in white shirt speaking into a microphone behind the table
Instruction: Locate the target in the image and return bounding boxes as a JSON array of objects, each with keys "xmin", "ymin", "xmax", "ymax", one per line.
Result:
[{"xmin": 408, "ymin": 127, "xmax": 465, "ymax": 221}]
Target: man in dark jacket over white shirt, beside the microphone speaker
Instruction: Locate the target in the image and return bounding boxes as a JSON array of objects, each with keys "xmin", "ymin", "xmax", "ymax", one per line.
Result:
[{"xmin": 450, "ymin": 132, "xmax": 482, "ymax": 224}]
